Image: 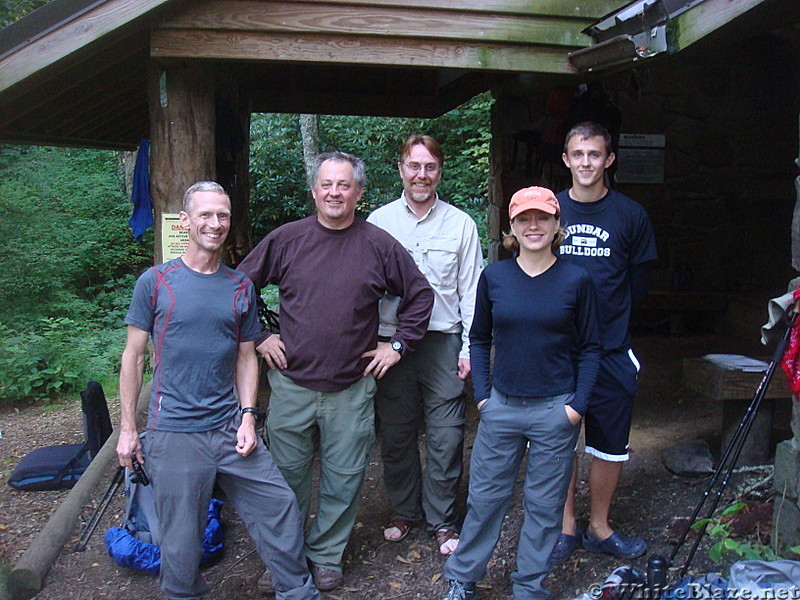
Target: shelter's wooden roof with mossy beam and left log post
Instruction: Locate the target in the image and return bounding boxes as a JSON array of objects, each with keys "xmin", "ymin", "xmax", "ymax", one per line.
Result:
[{"xmin": 0, "ymin": 0, "xmax": 793, "ymax": 261}]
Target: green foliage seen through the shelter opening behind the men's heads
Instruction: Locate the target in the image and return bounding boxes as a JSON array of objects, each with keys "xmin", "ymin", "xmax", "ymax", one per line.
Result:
[{"xmin": 250, "ymin": 94, "xmax": 492, "ymax": 251}]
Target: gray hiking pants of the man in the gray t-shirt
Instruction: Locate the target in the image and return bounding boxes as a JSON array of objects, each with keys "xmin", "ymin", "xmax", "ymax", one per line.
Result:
[{"xmin": 145, "ymin": 414, "xmax": 320, "ymax": 600}]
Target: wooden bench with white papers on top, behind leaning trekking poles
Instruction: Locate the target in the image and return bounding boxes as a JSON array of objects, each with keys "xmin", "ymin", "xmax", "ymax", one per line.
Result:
[{"xmin": 683, "ymin": 357, "xmax": 792, "ymax": 465}]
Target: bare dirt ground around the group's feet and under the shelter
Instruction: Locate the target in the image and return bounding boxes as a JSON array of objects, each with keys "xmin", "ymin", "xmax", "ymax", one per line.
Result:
[{"xmin": 0, "ymin": 334, "xmax": 790, "ymax": 600}]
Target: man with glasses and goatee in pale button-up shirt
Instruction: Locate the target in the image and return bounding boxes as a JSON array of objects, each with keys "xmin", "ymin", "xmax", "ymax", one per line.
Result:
[{"xmin": 367, "ymin": 135, "xmax": 483, "ymax": 555}]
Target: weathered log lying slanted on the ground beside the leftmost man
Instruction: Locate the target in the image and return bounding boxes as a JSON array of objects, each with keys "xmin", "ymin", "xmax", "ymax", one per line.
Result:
[{"xmin": 8, "ymin": 383, "xmax": 151, "ymax": 600}]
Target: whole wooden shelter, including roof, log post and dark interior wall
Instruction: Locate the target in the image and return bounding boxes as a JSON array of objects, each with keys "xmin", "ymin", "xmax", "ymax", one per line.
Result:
[{"xmin": 0, "ymin": 0, "xmax": 800, "ymax": 584}]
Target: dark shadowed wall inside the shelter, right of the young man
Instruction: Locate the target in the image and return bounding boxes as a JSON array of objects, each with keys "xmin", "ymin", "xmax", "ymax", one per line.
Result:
[{"xmin": 604, "ymin": 37, "xmax": 800, "ymax": 299}]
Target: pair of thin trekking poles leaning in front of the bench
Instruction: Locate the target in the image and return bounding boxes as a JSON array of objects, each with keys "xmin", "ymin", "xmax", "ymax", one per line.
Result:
[{"xmin": 669, "ymin": 305, "xmax": 798, "ymax": 578}]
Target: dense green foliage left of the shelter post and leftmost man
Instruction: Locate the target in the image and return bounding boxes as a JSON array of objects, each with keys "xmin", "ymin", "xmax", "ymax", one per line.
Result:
[{"xmin": 0, "ymin": 147, "xmax": 152, "ymax": 402}]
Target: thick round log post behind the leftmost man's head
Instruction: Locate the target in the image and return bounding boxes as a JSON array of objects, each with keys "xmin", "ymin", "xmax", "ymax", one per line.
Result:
[{"xmin": 148, "ymin": 62, "xmax": 217, "ymax": 264}]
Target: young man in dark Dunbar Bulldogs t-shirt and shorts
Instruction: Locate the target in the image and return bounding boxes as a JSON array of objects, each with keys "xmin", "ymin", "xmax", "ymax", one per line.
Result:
[{"xmin": 551, "ymin": 122, "xmax": 656, "ymax": 563}]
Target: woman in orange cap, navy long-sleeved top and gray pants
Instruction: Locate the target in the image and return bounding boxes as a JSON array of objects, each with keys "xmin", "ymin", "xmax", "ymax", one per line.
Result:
[{"xmin": 444, "ymin": 187, "xmax": 600, "ymax": 600}]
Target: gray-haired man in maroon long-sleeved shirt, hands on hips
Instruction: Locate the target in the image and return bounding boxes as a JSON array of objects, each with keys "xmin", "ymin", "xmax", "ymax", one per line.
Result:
[{"xmin": 238, "ymin": 152, "xmax": 433, "ymax": 591}]
